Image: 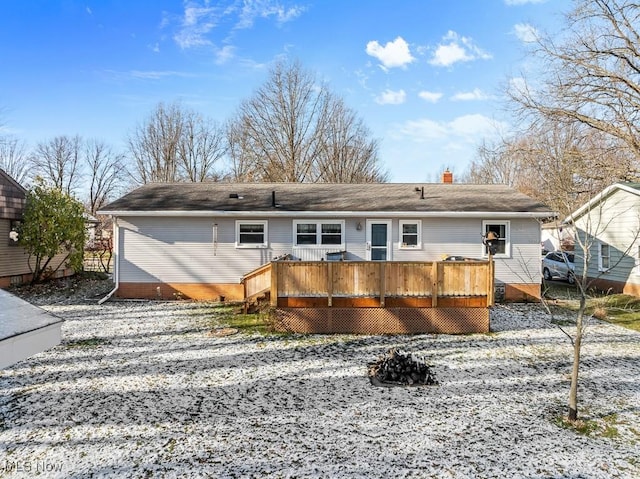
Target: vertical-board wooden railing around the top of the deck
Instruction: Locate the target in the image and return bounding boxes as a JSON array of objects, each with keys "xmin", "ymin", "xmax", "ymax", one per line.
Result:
[{"xmin": 258, "ymin": 261, "xmax": 494, "ymax": 307}]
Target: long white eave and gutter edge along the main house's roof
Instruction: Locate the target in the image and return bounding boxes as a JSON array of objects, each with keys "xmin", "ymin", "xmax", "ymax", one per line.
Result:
[{"xmin": 98, "ymin": 209, "xmax": 557, "ymax": 218}]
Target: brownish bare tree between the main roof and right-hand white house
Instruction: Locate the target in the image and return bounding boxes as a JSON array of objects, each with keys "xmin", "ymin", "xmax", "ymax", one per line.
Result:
[{"xmin": 464, "ymin": 120, "xmax": 635, "ymax": 217}]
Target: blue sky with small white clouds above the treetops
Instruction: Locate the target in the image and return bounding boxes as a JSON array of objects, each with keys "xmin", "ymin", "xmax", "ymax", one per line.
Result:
[{"xmin": 0, "ymin": 0, "xmax": 571, "ymax": 182}]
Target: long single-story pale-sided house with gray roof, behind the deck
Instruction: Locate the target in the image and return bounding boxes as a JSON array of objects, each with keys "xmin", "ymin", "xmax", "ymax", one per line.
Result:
[{"xmin": 100, "ymin": 177, "xmax": 554, "ymax": 300}]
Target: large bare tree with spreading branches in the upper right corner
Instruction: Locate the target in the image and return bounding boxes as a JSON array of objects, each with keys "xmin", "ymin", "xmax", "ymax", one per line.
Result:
[{"xmin": 508, "ymin": 0, "xmax": 640, "ymax": 171}]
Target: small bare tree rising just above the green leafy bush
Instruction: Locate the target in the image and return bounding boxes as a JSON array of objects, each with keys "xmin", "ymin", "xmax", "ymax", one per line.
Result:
[{"xmin": 30, "ymin": 135, "xmax": 82, "ymax": 195}]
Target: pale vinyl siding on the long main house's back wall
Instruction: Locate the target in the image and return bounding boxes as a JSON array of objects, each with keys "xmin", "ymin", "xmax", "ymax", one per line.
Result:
[{"xmin": 116, "ymin": 217, "xmax": 540, "ymax": 283}]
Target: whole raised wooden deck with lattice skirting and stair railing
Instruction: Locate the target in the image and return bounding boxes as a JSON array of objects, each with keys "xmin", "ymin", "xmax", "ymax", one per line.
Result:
[{"xmin": 243, "ymin": 261, "xmax": 494, "ymax": 334}]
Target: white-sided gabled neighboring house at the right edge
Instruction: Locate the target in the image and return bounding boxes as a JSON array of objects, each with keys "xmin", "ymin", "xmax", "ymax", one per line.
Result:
[{"xmin": 565, "ymin": 183, "xmax": 640, "ymax": 296}]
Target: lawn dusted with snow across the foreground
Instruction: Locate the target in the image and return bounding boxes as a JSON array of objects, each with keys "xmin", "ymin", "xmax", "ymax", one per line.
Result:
[{"xmin": 0, "ymin": 302, "xmax": 640, "ymax": 479}]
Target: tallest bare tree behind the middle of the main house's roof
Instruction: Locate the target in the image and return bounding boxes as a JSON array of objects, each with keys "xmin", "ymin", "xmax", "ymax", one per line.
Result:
[{"xmin": 227, "ymin": 58, "xmax": 386, "ymax": 182}]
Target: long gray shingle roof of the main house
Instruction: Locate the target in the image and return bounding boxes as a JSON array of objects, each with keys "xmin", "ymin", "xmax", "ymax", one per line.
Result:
[{"xmin": 102, "ymin": 183, "xmax": 552, "ymax": 215}]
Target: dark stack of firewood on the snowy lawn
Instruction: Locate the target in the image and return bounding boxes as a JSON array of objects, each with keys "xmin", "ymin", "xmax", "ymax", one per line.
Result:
[{"xmin": 369, "ymin": 349, "xmax": 438, "ymax": 386}]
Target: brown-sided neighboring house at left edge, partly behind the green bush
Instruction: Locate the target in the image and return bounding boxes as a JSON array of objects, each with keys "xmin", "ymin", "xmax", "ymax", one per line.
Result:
[{"xmin": 0, "ymin": 169, "xmax": 73, "ymax": 288}]
